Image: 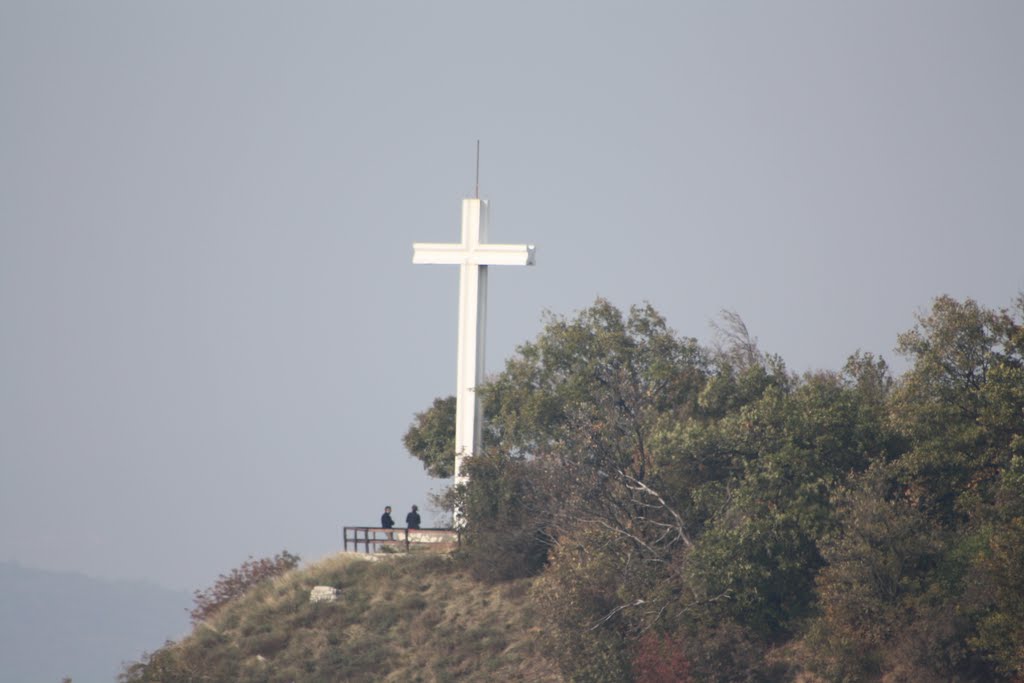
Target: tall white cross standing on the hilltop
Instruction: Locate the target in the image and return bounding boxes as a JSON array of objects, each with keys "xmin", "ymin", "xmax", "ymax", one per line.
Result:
[{"xmin": 413, "ymin": 199, "xmax": 534, "ymax": 507}]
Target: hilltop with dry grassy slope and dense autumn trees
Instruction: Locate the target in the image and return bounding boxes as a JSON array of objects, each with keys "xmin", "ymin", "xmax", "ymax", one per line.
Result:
[{"xmin": 125, "ymin": 297, "xmax": 1024, "ymax": 683}]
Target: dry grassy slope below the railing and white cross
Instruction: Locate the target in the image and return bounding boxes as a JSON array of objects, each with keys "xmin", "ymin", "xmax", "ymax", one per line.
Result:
[{"xmin": 125, "ymin": 554, "xmax": 562, "ymax": 683}]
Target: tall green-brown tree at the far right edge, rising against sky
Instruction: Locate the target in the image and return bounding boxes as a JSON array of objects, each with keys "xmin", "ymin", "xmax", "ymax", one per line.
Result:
[{"xmin": 892, "ymin": 297, "xmax": 1024, "ymax": 526}]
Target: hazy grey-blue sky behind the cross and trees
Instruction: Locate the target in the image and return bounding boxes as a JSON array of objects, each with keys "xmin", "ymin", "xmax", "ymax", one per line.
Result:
[{"xmin": 0, "ymin": 0, "xmax": 1024, "ymax": 589}]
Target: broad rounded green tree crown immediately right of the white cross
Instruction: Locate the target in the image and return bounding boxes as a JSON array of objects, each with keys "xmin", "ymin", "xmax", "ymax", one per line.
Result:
[{"xmin": 482, "ymin": 299, "xmax": 708, "ymax": 479}]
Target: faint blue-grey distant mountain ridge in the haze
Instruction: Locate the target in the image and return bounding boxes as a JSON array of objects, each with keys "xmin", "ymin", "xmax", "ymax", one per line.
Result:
[{"xmin": 0, "ymin": 562, "xmax": 191, "ymax": 683}]
